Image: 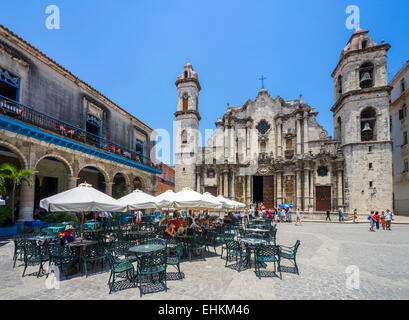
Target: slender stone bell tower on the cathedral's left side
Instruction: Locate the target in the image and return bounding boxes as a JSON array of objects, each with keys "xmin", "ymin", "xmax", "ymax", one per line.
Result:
[{"xmin": 174, "ymin": 63, "xmax": 201, "ymax": 192}]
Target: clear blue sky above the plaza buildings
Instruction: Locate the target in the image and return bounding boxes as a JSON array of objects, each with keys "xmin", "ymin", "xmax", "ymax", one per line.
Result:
[{"xmin": 0, "ymin": 0, "xmax": 409, "ymax": 164}]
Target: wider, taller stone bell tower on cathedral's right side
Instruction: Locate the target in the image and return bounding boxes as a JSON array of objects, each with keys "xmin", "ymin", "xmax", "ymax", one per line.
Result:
[{"xmin": 331, "ymin": 29, "xmax": 392, "ymax": 214}]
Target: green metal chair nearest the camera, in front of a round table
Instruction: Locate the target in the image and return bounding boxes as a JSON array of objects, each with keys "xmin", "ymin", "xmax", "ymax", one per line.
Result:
[{"xmin": 136, "ymin": 249, "xmax": 168, "ymax": 297}]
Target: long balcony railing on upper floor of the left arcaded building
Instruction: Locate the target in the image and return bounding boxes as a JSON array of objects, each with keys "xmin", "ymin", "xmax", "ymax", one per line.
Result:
[{"xmin": 0, "ymin": 95, "xmax": 162, "ymax": 170}]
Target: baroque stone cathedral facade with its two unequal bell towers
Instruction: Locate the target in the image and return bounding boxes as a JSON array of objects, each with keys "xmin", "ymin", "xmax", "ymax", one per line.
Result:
[{"xmin": 175, "ymin": 29, "xmax": 392, "ymax": 214}]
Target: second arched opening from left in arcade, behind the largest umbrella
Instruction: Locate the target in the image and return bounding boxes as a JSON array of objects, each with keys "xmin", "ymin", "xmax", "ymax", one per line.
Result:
[{"xmin": 34, "ymin": 156, "xmax": 68, "ymax": 207}]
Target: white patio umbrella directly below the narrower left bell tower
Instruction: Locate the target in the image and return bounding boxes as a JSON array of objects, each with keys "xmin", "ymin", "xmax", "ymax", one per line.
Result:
[{"xmin": 175, "ymin": 188, "xmax": 221, "ymax": 209}]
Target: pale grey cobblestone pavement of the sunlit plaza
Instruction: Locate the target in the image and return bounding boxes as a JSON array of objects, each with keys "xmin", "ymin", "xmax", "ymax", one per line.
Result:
[{"xmin": 0, "ymin": 223, "xmax": 409, "ymax": 300}]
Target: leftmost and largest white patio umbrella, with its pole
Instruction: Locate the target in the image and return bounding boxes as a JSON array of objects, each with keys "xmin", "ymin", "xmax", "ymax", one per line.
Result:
[{"xmin": 40, "ymin": 182, "xmax": 127, "ymax": 241}]
